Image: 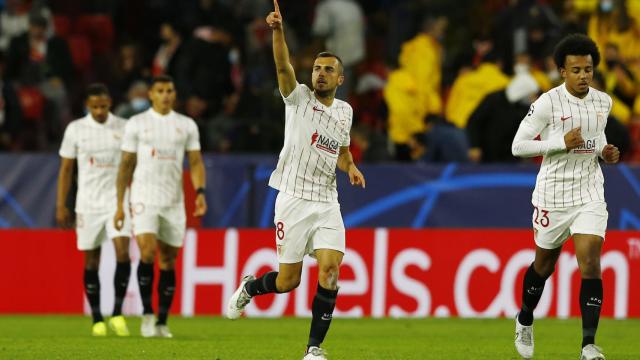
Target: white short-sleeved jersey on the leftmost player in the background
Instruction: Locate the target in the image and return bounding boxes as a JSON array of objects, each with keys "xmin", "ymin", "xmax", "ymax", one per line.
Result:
[{"xmin": 59, "ymin": 114, "xmax": 127, "ymax": 213}]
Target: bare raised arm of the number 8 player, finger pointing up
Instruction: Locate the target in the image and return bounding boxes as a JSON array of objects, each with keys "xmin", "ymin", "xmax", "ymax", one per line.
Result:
[{"xmin": 267, "ymin": 0, "xmax": 296, "ymax": 97}]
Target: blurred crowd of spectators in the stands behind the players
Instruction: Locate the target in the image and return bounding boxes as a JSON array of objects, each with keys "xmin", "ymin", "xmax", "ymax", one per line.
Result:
[{"xmin": 0, "ymin": 0, "xmax": 640, "ymax": 162}]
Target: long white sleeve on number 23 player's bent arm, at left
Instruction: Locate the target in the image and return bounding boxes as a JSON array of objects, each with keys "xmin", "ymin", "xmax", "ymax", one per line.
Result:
[{"xmin": 511, "ymin": 94, "xmax": 567, "ymax": 157}]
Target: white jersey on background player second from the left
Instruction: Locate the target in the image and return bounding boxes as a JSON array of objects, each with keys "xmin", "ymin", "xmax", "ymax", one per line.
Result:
[{"xmin": 122, "ymin": 109, "xmax": 200, "ymax": 206}]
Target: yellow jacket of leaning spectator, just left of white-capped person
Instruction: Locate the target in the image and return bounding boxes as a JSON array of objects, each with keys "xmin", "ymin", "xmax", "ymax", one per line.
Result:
[{"xmin": 445, "ymin": 53, "xmax": 509, "ymax": 129}]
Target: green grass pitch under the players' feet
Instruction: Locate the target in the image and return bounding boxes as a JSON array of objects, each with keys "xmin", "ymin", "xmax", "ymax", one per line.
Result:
[{"xmin": 0, "ymin": 316, "xmax": 640, "ymax": 360}]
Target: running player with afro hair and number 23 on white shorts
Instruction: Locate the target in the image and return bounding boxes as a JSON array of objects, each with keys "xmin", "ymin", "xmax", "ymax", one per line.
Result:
[{"xmin": 512, "ymin": 35, "xmax": 620, "ymax": 360}]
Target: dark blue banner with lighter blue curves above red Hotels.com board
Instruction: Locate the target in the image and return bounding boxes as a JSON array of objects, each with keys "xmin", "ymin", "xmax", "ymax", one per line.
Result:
[{"xmin": 0, "ymin": 154, "xmax": 640, "ymax": 230}]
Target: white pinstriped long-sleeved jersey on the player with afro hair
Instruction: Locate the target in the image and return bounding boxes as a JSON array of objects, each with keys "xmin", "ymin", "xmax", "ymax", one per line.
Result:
[{"xmin": 513, "ymin": 84, "xmax": 612, "ymax": 208}]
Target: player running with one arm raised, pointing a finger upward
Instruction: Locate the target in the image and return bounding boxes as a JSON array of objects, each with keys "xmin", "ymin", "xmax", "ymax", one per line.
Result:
[{"xmin": 227, "ymin": 0, "xmax": 365, "ymax": 359}]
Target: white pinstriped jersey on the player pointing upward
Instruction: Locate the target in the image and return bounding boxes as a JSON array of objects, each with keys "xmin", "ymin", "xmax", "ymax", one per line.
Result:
[{"xmin": 269, "ymin": 84, "xmax": 353, "ymax": 202}]
